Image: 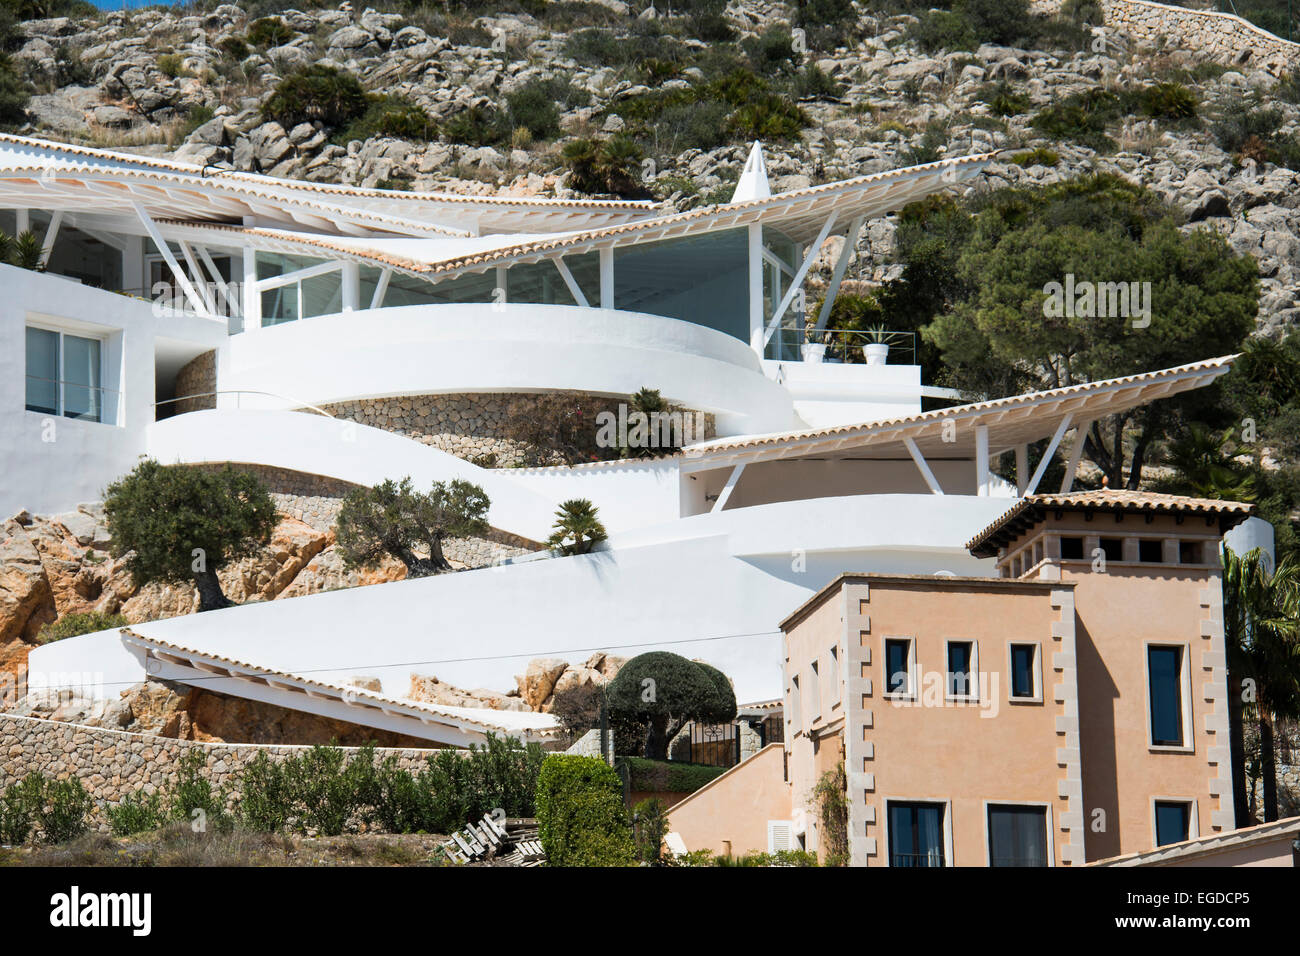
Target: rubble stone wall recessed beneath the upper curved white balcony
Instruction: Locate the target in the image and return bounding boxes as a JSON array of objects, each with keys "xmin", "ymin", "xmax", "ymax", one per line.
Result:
[{"xmin": 322, "ymin": 392, "xmax": 715, "ymax": 468}]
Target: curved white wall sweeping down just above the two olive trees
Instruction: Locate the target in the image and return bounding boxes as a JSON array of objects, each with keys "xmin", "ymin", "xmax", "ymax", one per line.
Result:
[{"xmin": 146, "ymin": 408, "xmax": 556, "ymax": 541}]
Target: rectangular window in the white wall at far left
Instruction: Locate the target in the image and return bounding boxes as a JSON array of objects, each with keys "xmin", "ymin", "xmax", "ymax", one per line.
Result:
[{"xmin": 26, "ymin": 326, "xmax": 104, "ymax": 421}]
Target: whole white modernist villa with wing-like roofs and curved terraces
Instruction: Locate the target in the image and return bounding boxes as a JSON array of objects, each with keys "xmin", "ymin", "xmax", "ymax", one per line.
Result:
[{"xmin": 0, "ymin": 137, "xmax": 1248, "ymax": 743}]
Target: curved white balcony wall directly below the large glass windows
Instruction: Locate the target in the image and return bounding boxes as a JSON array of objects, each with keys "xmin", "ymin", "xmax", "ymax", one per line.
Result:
[{"xmin": 217, "ymin": 303, "xmax": 798, "ymax": 434}]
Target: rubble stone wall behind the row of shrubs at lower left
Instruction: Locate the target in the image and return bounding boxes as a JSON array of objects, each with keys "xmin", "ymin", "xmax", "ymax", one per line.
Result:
[{"xmin": 0, "ymin": 714, "xmax": 438, "ymax": 830}]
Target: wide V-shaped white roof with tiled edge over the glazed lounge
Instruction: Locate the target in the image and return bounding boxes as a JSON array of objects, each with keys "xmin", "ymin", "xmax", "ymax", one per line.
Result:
[{"xmin": 144, "ymin": 153, "xmax": 993, "ymax": 280}]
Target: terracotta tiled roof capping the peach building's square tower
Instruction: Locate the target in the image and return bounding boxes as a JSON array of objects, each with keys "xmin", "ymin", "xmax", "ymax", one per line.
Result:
[{"xmin": 966, "ymin": 489, "xmax": 1255, "ymax": 558}]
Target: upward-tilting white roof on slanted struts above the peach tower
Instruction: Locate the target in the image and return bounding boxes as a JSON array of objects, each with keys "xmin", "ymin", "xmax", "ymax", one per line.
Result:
[{"xmin": 683, "ymin": 355, "xmax": 1236, "ymax": 471}]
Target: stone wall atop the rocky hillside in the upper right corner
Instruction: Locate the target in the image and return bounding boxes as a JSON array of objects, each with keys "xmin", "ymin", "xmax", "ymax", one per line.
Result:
[{"xmin": 1031, "ymin": 0, "xmax": 1300, "ymax": 75}]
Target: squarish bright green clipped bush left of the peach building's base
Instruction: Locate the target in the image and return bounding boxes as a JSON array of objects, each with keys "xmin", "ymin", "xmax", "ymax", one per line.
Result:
[{"xmin": 537, "ymin": 754, "xmax": 636, "ymax": 866}]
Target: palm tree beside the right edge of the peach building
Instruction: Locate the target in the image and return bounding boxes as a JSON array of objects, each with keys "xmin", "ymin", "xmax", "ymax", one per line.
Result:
[{"xmin": 1222, "ymin": 548, "xmax": 1300, "ymax": 825}]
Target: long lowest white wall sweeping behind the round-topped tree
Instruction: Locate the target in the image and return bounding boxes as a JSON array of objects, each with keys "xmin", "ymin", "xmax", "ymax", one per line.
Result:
[{"xmin": 30, "ymin": 496, "xmax": 1006, "ymax": 701}]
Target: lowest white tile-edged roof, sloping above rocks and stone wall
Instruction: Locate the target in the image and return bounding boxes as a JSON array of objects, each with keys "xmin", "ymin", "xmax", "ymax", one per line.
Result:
[{"xmin": 121, "ymin": 628, "xmax": 559, "ymax": 744}]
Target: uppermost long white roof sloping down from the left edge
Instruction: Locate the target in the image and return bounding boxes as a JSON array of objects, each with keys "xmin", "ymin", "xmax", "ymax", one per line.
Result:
[{"xmin": 0, "ymin": 134, "xmax": 657, "ymax": 235}]
